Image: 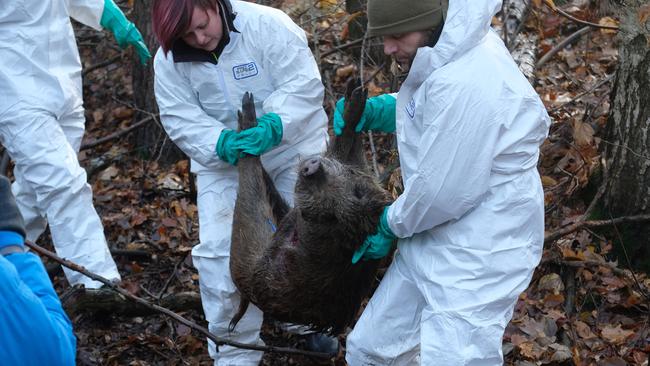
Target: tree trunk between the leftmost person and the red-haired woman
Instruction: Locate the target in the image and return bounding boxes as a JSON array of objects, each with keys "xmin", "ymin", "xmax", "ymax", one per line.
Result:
[{"xmin": 132, "ymin": 0, "xmax": 184, "ymax": 164}]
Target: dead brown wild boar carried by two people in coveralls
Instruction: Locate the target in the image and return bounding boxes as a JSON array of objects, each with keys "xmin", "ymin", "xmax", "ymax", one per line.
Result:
[{"xmin": 230, "ymin": 84, "xmax": 390, "ymax": 334}]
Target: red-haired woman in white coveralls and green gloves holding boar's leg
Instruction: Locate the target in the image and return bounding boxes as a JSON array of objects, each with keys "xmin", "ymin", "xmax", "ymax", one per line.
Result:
[{"xmin": 153, "ymin": 0, "xmax": 337, "ymax": 366}]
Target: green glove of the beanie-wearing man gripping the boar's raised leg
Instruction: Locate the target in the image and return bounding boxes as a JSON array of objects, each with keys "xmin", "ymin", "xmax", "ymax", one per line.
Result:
[{"xmin": 334, "ymin": 94, "xmax": 397, "ymax": 135}]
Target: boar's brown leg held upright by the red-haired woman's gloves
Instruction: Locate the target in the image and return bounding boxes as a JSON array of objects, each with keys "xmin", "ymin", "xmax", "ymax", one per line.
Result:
[{"xmin": 230, "ymin": 93, "xmax": 278, "ymax": 329}]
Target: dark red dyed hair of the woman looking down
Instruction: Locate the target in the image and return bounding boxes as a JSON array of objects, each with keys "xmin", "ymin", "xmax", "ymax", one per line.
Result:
[{"xmin": 151, "ymin": 0, "xmax": 217, "ymax": 55}]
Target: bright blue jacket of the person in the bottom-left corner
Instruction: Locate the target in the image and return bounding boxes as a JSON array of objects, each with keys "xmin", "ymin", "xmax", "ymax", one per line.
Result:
[{"xmin": 0, "ymin": 253, "xmax": 77, "ymax": 365}]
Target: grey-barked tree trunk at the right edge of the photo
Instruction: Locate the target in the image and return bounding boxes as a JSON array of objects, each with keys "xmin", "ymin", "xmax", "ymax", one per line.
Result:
[{"xmin": 603, "ymin": 0, "xmax": 650, "ymax": 268}]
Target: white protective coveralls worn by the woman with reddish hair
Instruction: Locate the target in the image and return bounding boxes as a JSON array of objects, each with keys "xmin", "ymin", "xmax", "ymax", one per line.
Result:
[{"xmin": 154, "ymin": 1, "xmax": 327, "ymax": 366}]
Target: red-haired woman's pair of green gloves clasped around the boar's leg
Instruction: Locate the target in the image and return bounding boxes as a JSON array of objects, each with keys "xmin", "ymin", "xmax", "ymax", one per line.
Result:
[{"xmin": 217, "ymin": 113, "xmax": 282, "ymax": 165}]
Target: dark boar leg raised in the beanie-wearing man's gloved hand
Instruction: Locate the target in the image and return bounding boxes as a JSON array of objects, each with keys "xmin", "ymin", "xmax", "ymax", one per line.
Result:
[{"xmin": 328, "ymin": 78, "xmax": 368, "ymax": 168}]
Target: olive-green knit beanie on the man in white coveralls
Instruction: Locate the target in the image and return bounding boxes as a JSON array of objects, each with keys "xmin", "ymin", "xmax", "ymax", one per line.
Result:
[{"xmin": 368, "ymin": 0, "xmax": 449, "ymax": 37}]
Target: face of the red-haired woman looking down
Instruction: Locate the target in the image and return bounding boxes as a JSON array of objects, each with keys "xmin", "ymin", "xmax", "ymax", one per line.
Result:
[{"xmin": 182, "ymin": 5, "xmax": 223, "ymax": 52}]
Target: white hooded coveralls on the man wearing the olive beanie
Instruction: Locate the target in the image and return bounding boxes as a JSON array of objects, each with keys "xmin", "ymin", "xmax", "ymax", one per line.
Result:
[{"xmin": 346, "ymin": 0, "xmax": 550, "ymax": 366}]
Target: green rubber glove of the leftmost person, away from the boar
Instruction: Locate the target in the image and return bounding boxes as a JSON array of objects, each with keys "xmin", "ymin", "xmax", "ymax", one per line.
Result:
[{"xmin": 99, "ymin": 0, "xmax": 151, "ymax": 65}]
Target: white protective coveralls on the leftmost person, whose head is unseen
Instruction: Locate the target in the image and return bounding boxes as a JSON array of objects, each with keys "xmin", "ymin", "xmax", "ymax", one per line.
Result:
[{"xmin": 0, "ymin": 0, "xmax": 120, "ymax": 288}]
